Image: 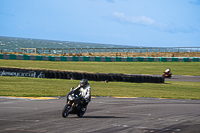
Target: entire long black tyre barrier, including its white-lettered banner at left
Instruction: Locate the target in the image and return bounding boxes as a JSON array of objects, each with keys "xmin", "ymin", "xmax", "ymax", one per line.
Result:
[{"xmin": 0, "ymin": 67, "xmax": 165, "ymax": 83}]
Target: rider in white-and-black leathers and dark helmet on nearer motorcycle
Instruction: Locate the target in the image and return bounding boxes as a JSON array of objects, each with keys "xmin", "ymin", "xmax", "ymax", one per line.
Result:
[{"xmin": 75, "ymin": 79, "xmax": 91, "ymax": 111}]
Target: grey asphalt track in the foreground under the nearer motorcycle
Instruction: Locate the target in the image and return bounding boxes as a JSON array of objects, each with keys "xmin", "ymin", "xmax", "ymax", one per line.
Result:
[{"xmin": 0, "ymin": 97, "xmax": 200, "ymax": 133}]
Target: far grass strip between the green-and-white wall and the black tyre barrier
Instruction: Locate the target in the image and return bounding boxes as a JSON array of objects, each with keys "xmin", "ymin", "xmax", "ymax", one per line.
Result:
[{"xmin": 0, "ymin": 59, "xmax": 200, "ymax": 76}]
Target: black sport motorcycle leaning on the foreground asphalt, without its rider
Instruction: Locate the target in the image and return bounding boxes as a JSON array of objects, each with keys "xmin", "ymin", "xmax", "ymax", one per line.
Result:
[{"xmin": 62, "ymin": 87, "xmax": 87, "ymax": 118}]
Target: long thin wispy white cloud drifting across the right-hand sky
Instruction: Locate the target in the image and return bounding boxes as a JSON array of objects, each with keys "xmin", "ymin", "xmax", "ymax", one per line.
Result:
[{"xmin": 112, "ymin": 12, "xmax": 195, "ymax": 33}]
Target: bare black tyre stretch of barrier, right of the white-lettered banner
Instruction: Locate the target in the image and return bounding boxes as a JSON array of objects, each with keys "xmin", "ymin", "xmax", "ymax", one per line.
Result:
[{"xmin": 44, "ymin": 71, "xmax": 165, "ymax": 83}]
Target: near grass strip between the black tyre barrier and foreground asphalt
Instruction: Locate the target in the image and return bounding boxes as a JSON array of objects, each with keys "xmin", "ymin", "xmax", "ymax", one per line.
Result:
[{"xmin": 0, "ymin": 76, "xmax": 200, "ymax": 99}]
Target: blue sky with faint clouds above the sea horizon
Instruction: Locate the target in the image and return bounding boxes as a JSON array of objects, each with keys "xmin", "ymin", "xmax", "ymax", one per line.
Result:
[{"xmin": 0, "ymin": 0, "xmax": 200, "ymax": 47}]
